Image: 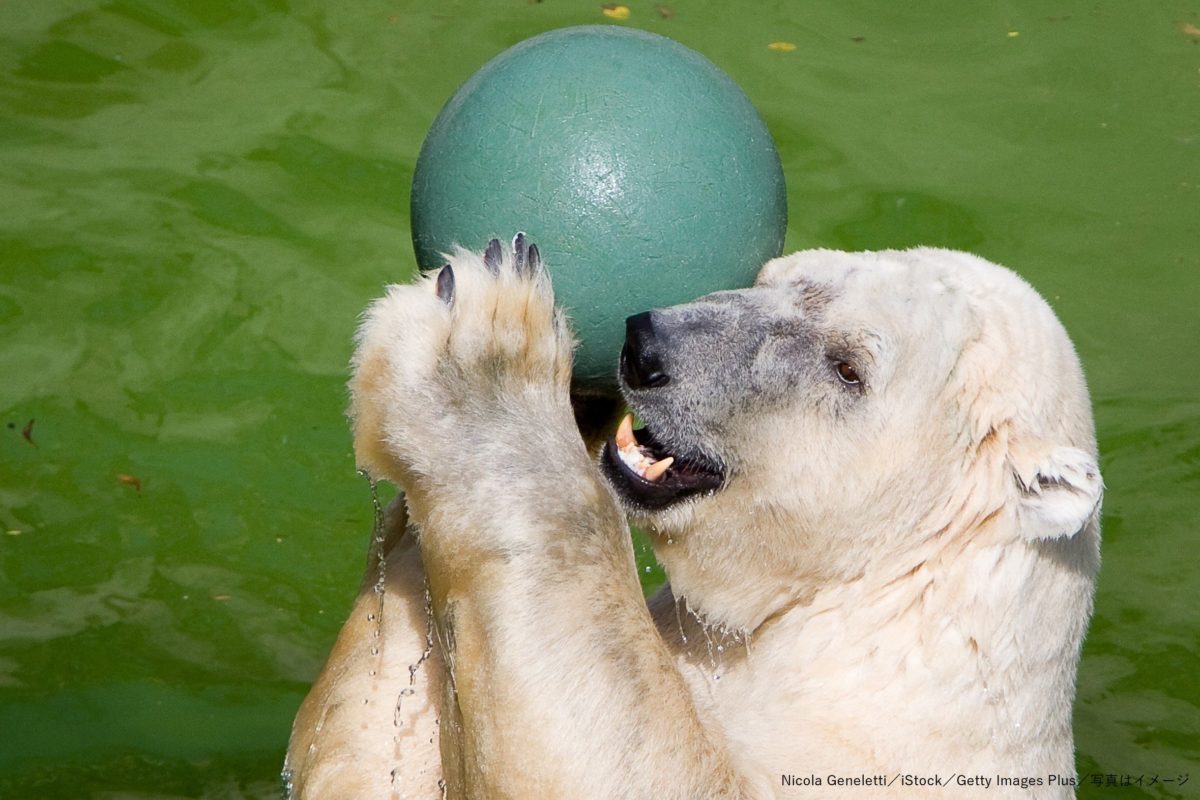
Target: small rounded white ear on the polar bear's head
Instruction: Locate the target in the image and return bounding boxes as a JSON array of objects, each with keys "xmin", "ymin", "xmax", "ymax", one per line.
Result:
[{"xmin": 1008, "ymin": 447, "xmax": 1104, "ymax": 540}]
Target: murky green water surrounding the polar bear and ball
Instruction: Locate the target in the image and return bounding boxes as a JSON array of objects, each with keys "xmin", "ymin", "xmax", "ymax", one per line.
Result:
[{"xmin": 0, "ymin": 0, "xmax": 1200, "ymax": 799}]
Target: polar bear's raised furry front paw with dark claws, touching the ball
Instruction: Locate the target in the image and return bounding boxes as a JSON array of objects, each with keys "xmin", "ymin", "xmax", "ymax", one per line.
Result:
[{"xmin": 350, "ymin": 234, "xmax": 572, "ymax": 486}]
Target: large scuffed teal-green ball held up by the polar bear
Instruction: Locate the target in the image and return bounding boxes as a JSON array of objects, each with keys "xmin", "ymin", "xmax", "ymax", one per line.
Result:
[{"xmin": 412, "ymin": 25, "xmax": 787, "ymax": 392}]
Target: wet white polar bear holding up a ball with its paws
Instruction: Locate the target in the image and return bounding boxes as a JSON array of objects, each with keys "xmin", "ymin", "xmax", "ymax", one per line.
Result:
[{"xmin": 287, "ymin": 236, "xmax": 1103, "ymax": 800}]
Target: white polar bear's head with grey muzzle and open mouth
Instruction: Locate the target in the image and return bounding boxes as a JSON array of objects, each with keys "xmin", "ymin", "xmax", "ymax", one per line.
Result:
[{"xmin": 601, "ymin": 248, "xmax": 1103, "ymax": 628}]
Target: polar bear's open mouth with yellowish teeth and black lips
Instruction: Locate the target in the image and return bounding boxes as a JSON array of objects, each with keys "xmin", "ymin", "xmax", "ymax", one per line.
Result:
[{"xmin": 600, "ymin": 415, "xmax": 725, "ymax": 511}]
